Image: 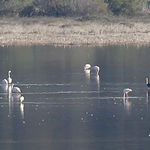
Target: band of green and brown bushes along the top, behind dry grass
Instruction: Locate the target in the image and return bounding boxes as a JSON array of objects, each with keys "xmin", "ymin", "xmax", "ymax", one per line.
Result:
[{"xmin": 0, "ymin": 0, "xmax": 148, "ymax": 18}]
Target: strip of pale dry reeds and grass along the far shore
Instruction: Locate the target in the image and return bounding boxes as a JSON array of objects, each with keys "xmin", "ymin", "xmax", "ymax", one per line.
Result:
[{"xmin": 0, "ymin": 17, "xmax": 150, "ymax": 46}]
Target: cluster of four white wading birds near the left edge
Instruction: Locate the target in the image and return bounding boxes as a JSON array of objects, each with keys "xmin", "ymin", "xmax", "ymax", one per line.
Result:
[{"xmin": 1, "ymin": 70, "xmax": 24, "ymax": 103}]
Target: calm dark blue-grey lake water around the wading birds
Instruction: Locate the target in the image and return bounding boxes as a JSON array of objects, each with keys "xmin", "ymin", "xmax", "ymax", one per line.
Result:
[{"xmin": 0, "ymin": 46, "xmax": 150, "ymax": 150}]
